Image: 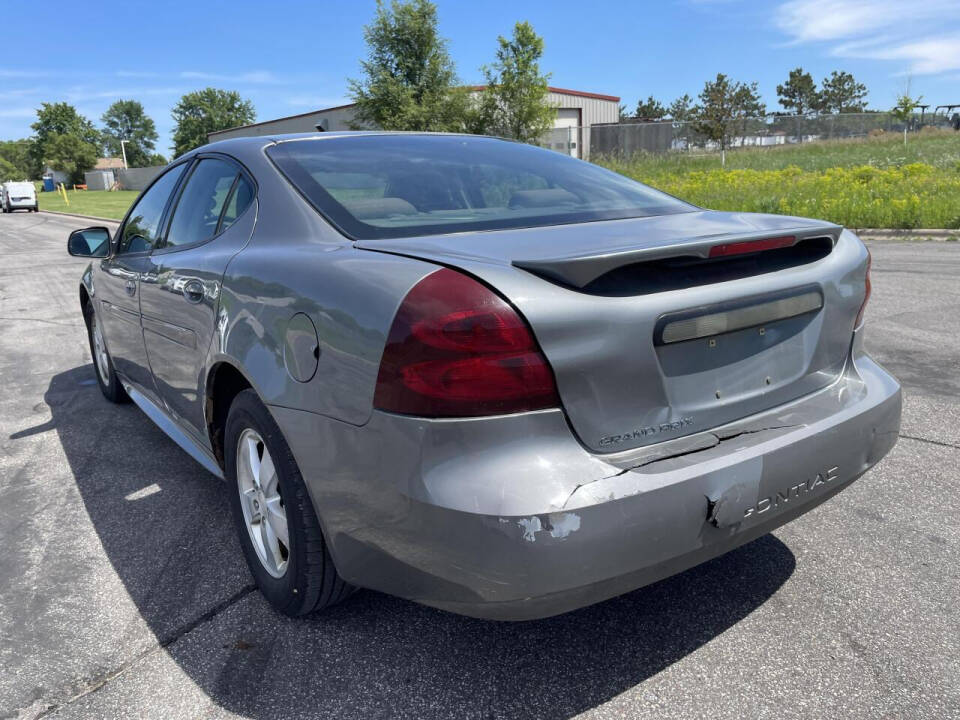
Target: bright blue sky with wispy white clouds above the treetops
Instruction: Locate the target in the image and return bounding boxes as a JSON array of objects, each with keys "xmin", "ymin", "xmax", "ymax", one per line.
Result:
[{"xmin": 0, "ymin": 0, "xmax": 960, "ymax": 154}]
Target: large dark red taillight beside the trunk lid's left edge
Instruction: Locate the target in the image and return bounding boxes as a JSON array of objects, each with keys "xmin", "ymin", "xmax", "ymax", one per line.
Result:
[{"xmin": 373, "ymin": 268, "xmax": 560, "ymax": 417}]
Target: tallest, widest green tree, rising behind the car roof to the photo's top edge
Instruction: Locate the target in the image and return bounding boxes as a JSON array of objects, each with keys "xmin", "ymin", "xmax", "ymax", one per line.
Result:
[{"xmin": 349, "ymin": 0, "xmax": 469, "ymax": 131}]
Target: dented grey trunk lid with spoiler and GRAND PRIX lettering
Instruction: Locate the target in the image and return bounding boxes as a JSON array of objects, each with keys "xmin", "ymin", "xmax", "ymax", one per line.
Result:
[{"xmin": 357, "ymin": 211, "xmax": 867, "ymax": 452}]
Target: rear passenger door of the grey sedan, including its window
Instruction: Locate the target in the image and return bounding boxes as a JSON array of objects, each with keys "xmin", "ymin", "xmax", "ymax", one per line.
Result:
[{"xmin": 140, "ymin": 155, "xmax": 255, "ymax": 438}]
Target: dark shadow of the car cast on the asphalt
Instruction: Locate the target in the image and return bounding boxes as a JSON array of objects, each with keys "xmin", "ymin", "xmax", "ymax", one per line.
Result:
[{"xmin": 39, "ymin": 365, "xmax": 795, "ymax": 718}]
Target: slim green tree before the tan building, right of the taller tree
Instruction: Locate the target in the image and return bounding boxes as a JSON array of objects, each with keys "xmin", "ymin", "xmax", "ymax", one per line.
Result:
[{"xmin": 479, "ymin": 22, "xmax": 557, "ymax": 142}]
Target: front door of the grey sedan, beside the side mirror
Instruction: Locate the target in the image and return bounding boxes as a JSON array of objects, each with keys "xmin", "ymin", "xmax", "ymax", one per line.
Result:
[{"xmin": 93, "ymin": 163, "xmax": 187, "ymax": 389}]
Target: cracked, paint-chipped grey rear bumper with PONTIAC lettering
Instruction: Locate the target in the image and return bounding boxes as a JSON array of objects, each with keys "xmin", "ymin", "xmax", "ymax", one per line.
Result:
[{"xmin": 271, "ymin": 340, "xmax": 901, "ymax": 620}]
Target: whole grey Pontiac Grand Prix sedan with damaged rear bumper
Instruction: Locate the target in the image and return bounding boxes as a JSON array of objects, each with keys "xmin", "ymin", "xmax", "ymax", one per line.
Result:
[{"xmin": 68, "ymin": 133, "xmax": 901, "ymax": 620}]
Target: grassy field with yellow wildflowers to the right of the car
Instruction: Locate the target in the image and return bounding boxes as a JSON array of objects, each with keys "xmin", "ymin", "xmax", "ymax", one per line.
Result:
[{"xmin": 599, "ymin": 131, "xmax": 960, "ymax": 228}]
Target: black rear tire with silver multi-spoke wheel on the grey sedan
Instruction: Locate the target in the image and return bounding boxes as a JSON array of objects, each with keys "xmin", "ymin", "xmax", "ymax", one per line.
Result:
[{"xmin": 224, "ymin": 390, "xmax": 354, "ymax": 616}]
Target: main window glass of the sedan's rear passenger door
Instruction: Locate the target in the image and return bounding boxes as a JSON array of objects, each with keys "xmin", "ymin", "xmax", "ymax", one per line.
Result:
[{"xmin": 166, "ymin": 158, "xmax": 239, "ymax": 247}]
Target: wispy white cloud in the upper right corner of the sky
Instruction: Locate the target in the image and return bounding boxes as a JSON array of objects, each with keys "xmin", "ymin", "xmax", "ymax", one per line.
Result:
[{"xmin": 774, "ymin": 0, "xmax": 960, "ymax": 75}]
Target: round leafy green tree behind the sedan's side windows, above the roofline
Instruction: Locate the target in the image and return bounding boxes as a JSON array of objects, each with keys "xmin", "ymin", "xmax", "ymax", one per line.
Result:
[{"xmin": 171, "ymin": 88, "xmax": 257, "ymax": 157}]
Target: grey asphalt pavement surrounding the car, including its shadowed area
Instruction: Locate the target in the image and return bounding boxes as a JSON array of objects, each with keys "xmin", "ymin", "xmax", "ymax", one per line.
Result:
[{"xmin": 0, "ymin": 213, "xmax": 960, "ymax": 719}]
